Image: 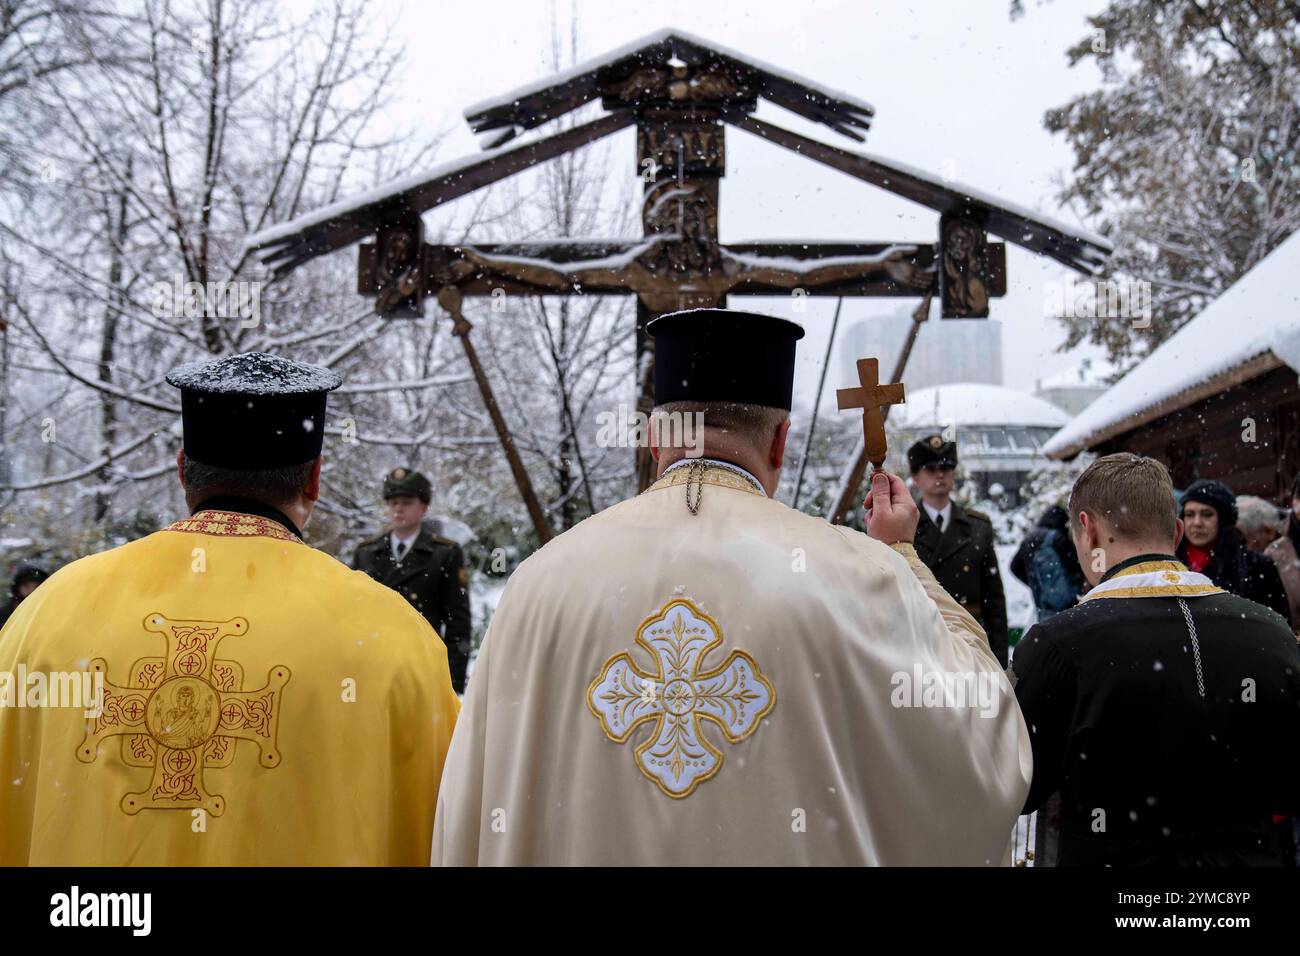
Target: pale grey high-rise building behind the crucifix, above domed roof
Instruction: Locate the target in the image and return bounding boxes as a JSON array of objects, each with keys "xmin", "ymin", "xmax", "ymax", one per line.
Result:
[{"xmin": 840, "ymin": 308, "xmax": 1002, "ymax": 392}]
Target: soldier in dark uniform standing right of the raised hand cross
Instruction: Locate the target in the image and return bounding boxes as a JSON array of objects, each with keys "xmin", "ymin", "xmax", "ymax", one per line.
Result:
[{"xmin": 907, "ymin": 434, "xmax": 1006, "ymax": 667}]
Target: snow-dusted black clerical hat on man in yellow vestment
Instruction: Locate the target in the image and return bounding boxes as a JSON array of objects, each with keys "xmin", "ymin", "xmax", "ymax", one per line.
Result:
[{"xmin": 166, "ymin": 352, "xmax": 342, "ymax": 471}]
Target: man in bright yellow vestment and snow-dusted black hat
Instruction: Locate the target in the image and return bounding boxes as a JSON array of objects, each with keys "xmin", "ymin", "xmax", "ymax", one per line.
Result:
[{"xmin": 0, "ymin": 352, "xmax": 458, "ymax": 866}]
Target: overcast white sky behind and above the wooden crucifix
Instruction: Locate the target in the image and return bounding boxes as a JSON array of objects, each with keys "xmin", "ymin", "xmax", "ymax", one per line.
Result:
[{"xmin": 364, "ymin": 0, "xmax": 1104, "ymax": 403}]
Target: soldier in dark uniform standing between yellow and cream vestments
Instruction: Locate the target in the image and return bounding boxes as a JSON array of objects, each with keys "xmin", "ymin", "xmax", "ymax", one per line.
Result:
[{"xmin": 352, "ymin": 468, "xmax": 469, "ymax": 693}]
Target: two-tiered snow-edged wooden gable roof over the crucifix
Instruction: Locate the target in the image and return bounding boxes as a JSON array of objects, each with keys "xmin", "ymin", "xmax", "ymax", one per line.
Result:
[{"xmin": 246, "ymin": 29, "xmax": 1112, "ymax": 287}]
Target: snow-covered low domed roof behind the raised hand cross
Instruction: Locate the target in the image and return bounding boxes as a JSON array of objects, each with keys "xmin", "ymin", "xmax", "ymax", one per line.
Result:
[{"xmin": 889, "ymin": 376, "xmax": 1070, "ymax": 432}]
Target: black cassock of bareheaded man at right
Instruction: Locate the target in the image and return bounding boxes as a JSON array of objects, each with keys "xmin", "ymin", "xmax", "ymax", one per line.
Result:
[{"xmin": 1013, "ymin": 554, "xmax": 1300, "ymax": 866}]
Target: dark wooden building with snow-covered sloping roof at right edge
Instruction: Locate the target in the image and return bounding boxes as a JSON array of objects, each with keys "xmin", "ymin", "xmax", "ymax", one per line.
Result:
[{"xmin": 1044, "ymin": 233, "xmax": 1300, "ymax": 499}]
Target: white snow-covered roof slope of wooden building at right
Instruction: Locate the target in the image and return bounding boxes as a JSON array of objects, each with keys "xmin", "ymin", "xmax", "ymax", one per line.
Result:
[{"xmin": 1044, "ymin": 232, "xmax": 1300, "ymax": 458}]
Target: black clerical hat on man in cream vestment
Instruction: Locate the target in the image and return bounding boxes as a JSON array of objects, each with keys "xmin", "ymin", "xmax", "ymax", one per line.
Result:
[{"xmin": 646, "ymin": 308, "xmax": 803, "ymax": 410}]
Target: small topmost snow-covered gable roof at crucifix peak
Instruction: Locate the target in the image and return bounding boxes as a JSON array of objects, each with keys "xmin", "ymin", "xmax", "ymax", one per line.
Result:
[{"xmin": 464, "ymin": 27, "xmax": 876, "ymax": 147}]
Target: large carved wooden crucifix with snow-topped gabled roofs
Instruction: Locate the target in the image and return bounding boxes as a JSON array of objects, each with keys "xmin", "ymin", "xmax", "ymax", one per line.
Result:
[{"xmin": 246, "ymin": 30, "xmax": 1110, "ymax": 540}]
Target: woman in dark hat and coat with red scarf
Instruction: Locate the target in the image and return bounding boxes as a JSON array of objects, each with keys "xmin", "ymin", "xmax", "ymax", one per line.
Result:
[{"xmin": 1178, "ymin": 479, "xmax": 1291, "ymax": 623}]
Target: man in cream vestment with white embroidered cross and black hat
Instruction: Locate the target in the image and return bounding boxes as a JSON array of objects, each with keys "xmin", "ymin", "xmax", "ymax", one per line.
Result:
[{"xmin": 433, "ymin": 310, "xmax": 1032, "ymax": 865}]
